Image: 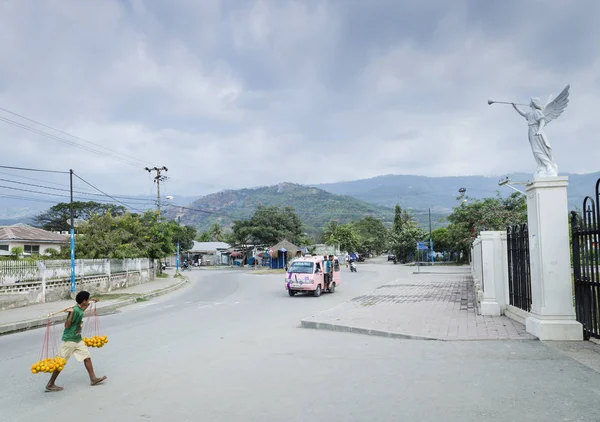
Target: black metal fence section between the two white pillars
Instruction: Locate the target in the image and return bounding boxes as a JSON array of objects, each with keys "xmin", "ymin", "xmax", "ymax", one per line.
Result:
[{"xmin": 506, "ymin": 224, "xmax": 531, "ymax": 312}]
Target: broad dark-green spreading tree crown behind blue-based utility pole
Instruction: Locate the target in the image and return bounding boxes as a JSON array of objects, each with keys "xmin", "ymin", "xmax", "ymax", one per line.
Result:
[{"xmin": 33, "ymin": 201, "xmax": 126, "ymax": 231}]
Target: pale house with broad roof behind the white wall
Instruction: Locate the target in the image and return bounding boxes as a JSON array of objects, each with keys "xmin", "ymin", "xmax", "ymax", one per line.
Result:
[{"xmin": 0, "ymin": 224, "xmax": 69, "ymax": 256}]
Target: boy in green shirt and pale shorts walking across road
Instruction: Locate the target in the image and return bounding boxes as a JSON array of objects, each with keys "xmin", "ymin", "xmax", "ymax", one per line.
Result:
[{"xmin": 46, "ymin": 291, "xmax": 106, "ymax": 392}]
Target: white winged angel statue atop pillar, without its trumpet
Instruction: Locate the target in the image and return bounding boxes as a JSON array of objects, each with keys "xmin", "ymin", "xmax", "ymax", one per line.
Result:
[{"xmin": 511, "ymin": 85, "xmax": 570, "ymax": 178}]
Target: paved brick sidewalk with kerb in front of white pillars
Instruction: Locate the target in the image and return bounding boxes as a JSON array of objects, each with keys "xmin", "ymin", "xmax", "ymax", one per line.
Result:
[{"xmin": 301, "ymin": 267, "xmax": 535, "ymax": 340}]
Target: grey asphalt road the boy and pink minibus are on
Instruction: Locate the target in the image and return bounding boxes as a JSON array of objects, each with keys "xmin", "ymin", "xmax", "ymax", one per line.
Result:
[{"xmin": 0, "ymin": 262, "xmax": 600, "ymax": 422}]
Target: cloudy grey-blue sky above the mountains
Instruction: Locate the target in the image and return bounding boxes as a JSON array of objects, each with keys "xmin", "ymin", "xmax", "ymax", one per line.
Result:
[{"xmin": 0, "ymin": 0, "xmax": 600, "ymax": 204}]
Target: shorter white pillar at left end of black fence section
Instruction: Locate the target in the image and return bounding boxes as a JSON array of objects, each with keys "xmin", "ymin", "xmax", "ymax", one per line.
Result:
[{"xmin": 479, "ymin": 231, "xmax": 508, "ymax": 316}]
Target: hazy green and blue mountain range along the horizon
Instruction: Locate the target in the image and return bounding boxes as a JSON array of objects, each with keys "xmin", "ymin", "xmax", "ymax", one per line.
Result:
[{"xmin": 0, "ymin": 172, "xmax": 600, "ymax": 233}]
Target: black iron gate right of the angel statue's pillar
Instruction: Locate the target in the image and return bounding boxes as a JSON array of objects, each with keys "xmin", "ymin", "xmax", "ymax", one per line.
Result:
[{"xmin": 571, "ymin": 179, "xmax": 600, "ymax": 338}]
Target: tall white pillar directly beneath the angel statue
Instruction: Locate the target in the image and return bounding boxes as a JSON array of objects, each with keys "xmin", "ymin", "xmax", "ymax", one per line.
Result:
[{"xmin": 525, "ymin": 177, "xmax": 583, "ymax": 340}]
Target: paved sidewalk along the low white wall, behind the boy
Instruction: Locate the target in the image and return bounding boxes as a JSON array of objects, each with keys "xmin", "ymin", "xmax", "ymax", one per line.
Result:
[{"xmin": 0, "ymin": 277, "xmax": 187, "ymax": 335}]
